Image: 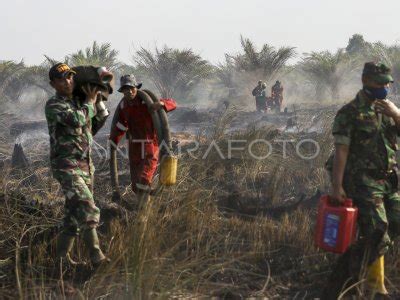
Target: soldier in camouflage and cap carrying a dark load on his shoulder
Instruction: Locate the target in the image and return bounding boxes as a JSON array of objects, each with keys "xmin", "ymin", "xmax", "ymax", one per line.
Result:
[{"xmin": 45, "ymin": 63, "xmax": 108, "ymax": 265}]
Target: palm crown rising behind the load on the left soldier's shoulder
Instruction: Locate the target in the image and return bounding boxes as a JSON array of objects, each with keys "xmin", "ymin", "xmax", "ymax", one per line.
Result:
[{"xmin": 66, "ymin": 41, "xmax": 120, "ymax": 71}]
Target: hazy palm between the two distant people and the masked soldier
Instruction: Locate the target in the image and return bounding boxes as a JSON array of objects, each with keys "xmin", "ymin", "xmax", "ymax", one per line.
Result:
[{"xmin": 300, "ymin": 49, "xmax": 356, "ymax": 99}]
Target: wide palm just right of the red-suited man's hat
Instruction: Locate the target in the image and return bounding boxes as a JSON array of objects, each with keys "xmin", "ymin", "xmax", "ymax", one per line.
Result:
[{"xmin": 133, "ymin": 46, "xmax": 213, "ymax": 99}]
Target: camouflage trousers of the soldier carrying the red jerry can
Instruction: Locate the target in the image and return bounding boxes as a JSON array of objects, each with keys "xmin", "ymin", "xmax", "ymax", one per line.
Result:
[{"xmin": 321, "ymin": 173, "xmax": 400, "ymax": 299}]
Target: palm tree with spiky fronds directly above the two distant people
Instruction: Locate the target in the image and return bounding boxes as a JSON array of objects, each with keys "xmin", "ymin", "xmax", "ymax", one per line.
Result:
[{"xmin": 228, "ymin": 36, "xmax": 296, "ymax": 81}]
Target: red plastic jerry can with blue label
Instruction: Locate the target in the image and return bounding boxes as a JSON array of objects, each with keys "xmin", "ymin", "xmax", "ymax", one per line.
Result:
[{"xmin": 315, "ymin": 195, "xmax": 358, "ymax": 253}]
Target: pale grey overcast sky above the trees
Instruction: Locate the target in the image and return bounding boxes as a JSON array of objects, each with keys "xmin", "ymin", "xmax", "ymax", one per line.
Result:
[{"xmin": 0, "ymin": 0, "xmax": 400, "ymax": 64}]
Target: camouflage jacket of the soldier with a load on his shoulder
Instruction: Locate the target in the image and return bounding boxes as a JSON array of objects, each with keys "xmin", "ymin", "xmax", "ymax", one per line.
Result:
[{"xmin": 45, "ymin": 95, "xmax": 106, "ymax": 173}]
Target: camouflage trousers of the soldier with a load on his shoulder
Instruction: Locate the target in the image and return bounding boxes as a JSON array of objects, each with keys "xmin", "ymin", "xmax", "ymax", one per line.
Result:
[{"xmin": 53, "ymin": 168, "xmax": 100, "ymax": 235}]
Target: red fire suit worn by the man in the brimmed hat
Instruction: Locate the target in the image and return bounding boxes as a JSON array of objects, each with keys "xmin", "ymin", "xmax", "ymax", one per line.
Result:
[{"xmin": 110, "ymin": 96, "xmax": 176, "ymax": 192}]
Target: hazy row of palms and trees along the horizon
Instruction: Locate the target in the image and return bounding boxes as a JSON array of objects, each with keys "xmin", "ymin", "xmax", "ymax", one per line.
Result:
[{"xmin": 0, "ymin": 34, "xmax": 400, "ymax": 102}]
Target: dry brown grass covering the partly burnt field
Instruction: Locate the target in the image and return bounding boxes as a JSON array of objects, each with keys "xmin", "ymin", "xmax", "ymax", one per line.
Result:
[{"xmin": 0, "ymin": 108, "xmax": 400, "ymax": 299}]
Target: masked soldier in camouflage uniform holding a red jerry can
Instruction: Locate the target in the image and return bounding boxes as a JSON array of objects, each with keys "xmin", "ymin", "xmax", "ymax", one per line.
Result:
[{"xmin": 321, "ymin": 62, "xmax": 400, "ymax": 299}]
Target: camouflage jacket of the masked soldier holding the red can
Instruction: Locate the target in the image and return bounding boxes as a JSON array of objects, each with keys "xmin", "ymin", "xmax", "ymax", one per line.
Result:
[{"xmin": 328, "ymin": 90, "xmax": 399, "ymax": 176}]
